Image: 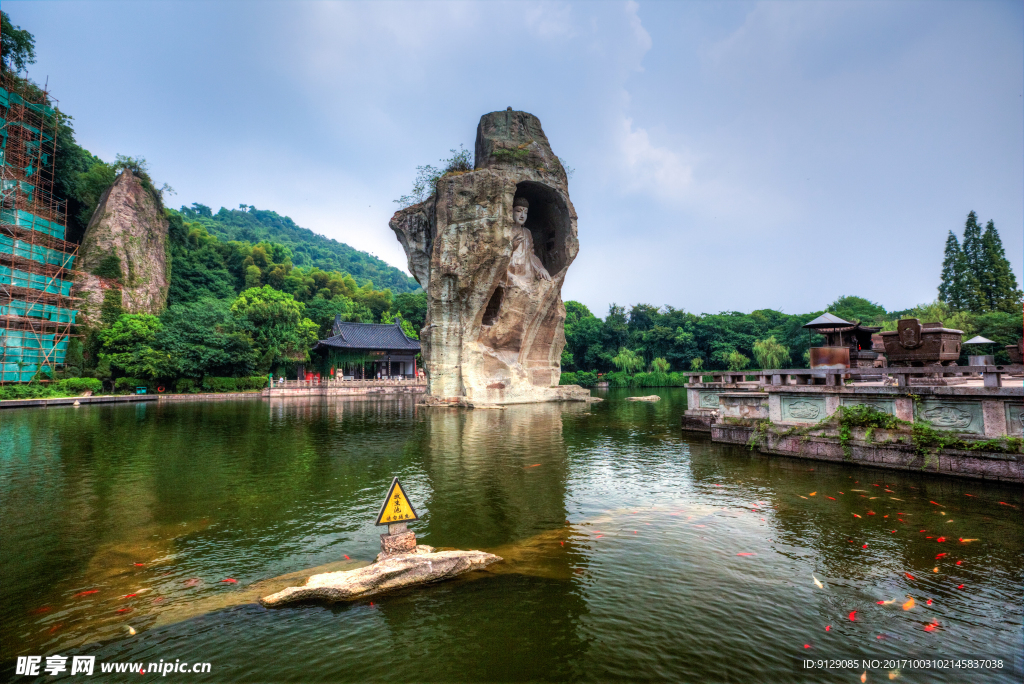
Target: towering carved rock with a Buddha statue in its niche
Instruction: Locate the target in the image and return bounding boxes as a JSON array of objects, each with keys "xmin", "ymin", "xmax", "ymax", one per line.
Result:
[{"xmin": 390, "ymin": 109, "xmax": 590, "ymax": 405}]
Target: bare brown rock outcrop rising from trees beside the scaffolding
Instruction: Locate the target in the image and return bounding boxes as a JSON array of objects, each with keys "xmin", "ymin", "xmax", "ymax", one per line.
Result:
[{"xmin": 75, "ymin": 169, "xmax": 169, "ymax": 323}]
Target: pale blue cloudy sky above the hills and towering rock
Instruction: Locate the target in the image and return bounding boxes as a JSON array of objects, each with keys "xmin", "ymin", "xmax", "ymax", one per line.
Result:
[{"xmin": 3, "ymin": 0, "xmax": 1024, "ymax": 315}]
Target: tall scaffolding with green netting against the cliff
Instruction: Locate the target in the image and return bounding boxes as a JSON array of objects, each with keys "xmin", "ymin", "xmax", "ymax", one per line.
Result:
[{"xmin": 0, "ymin": 73, "xmax": 78, "ymax": 384}]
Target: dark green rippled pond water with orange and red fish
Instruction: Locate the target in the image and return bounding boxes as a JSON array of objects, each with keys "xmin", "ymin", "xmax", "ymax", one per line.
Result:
[{"xmin": 0, "ymin": 389, "xmax": 1024, "ymax": 683}]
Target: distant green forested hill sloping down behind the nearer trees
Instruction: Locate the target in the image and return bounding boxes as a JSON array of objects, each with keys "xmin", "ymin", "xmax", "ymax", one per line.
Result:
[{"xmin": 181, "ymin": 204, "xmax": 420, "ymax": 294}]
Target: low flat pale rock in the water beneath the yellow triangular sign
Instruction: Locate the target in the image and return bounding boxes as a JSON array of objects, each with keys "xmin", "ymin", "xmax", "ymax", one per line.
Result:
[{"xmin": 259, "ymin": 547, "xmax": 501, "ymax": 607}]
